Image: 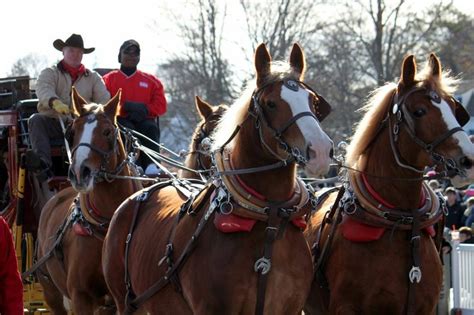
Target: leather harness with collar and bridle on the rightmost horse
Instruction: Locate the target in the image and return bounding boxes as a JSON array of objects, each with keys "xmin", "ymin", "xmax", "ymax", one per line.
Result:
[{"xmin": 312, "ymin": 87, "xmax": 466, "ymax": 314}]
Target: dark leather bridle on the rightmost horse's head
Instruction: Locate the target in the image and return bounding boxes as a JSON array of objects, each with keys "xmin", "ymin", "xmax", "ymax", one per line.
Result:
[{"xmin": 386, "ymin": 87, "xmax": 469, "ymax": 176}]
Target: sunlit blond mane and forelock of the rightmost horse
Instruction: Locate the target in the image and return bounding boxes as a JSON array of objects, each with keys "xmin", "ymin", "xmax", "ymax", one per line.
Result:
[{"xmin": 346, "ymin": 58, "xmax": 459, "ymax": 167}]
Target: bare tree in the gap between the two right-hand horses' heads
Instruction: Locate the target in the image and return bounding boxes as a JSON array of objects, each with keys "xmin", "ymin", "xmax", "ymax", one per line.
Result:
[{"xmin": 307, "ymin": 0, "xmax": 462, "ymax": 141}]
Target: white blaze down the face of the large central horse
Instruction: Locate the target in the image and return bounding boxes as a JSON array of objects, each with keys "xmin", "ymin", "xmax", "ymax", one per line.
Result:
[{"xmin": 281, "ymin": 85, "xmax": 333, "ymax": 175}]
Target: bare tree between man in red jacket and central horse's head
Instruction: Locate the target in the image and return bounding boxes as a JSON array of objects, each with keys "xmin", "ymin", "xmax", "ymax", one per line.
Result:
[{"xmin": 159, "ymin": 0, "xmax": 235, "ymax": 152}]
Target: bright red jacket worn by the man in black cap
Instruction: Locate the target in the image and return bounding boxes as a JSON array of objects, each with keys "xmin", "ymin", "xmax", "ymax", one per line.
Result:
[{"xmin": 103, "ymin": 70, "xmax": 166, "ymax": 118}]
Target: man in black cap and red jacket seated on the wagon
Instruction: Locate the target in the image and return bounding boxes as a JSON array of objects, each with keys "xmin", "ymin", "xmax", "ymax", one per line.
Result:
[{"xmin": 104, "ymin": 39, "xmax": 166, "ymax": 175}]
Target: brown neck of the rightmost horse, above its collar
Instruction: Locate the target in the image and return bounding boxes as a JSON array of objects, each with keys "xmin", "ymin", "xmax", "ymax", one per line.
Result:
[{"xmin": 356, "ymin": 128, "xmax": 422, "ymax": 209}]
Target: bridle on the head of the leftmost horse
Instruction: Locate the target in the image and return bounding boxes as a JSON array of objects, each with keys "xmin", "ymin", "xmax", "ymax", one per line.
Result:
[{"xmin": 65, "ymin": 113, "xmax": 129, "ymax": 183}]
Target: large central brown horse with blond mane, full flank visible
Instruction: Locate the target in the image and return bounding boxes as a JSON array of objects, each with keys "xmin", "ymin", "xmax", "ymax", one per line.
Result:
[{"xmin": 102, "ymin": 44, "xmax": 333, "ymax": 314}]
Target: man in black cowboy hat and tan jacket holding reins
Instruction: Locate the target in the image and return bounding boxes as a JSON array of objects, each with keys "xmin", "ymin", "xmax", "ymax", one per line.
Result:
[{"xmin": 27, "ymin": 34, "xmax": 110, "ymax": 179}]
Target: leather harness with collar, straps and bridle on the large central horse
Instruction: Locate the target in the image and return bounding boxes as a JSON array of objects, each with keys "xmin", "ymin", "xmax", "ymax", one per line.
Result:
[{"xmin": 120, "ymin": 80, "xmax": 330, "ymax": 315}]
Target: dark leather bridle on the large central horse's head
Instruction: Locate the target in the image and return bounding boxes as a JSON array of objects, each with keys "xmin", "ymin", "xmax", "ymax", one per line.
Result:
[{"xmin": 248, "ymin": 79, "xmax": 331, "ymax": 165}]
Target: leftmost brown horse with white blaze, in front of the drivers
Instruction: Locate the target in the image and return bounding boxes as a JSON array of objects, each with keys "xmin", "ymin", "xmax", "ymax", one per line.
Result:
[{"xmin": 37, "ymin": 87, "xmax": 141, "ymax": 315}]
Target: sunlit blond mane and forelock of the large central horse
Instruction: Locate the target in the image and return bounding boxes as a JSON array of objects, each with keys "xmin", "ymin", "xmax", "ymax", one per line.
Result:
[{"xmin": 211, "ymin": 61, "xmax": 301, "ymax": 151}]
